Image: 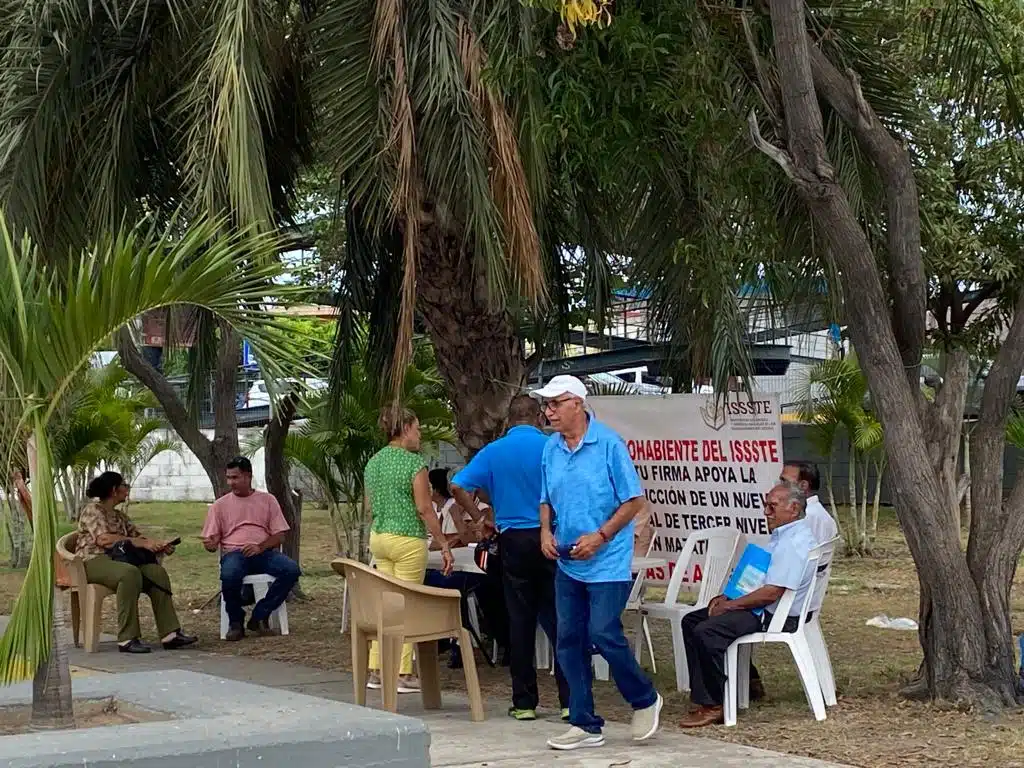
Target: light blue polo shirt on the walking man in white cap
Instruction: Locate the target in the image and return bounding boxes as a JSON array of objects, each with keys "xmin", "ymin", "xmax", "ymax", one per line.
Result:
[{"xmin": 541, "ymin": 416, "xmax": 643, "ymax": 584}]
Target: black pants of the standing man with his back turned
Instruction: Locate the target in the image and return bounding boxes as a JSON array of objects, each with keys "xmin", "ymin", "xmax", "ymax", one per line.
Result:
[{"xmin": 499, "ymin": 528, "xmax": 569, "ymax": 710}]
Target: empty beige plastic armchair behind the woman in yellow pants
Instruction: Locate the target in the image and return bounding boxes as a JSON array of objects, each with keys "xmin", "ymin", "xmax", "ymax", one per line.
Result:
[{"xmin": 331, "ymin": 558, "xmax": 484, "ymax": 722}]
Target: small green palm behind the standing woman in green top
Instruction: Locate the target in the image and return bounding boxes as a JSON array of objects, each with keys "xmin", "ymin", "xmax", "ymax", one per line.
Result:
[{"xmin": 285, "ymin": 332, "xmax": 456, "ymax": 560}]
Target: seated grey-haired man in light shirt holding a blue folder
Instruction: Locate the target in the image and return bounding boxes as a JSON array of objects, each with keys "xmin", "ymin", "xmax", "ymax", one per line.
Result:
[{"xmin": 679, "ymin": 483, "xmax": 817, "ymax": 728}]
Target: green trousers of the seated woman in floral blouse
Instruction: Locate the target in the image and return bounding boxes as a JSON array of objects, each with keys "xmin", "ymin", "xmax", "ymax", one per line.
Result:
[{"xmin": 85, "ymin": 555, "xmax": 181, "ymax": 643}]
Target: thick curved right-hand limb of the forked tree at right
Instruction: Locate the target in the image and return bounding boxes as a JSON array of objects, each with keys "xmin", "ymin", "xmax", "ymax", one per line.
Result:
[{"xmin": 809, "ymin": 46, "xmax": 928, "ymax": 387}]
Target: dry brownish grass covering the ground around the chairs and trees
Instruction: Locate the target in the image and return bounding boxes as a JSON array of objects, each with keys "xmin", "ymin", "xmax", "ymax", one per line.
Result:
[{"xmin": 0, "ymin": 504, "xmax": 1024, "ymax": 768}]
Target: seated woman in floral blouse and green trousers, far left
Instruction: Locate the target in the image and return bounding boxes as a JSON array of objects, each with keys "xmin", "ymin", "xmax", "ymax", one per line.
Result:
[{"xmin": 76, "ymin": 472, "xmax": 198, "ymax": 653}]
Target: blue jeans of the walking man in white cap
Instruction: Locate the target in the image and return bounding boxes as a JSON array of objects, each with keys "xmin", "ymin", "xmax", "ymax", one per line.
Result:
[{"xmin": 555, "ymin": 568, "xmax": 657, "ymax": 733}]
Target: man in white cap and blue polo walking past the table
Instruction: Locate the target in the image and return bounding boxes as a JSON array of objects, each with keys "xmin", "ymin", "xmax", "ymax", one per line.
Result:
[{"xmin": 532, "ymin": 376, "xmax": 663, "ymax": 750}]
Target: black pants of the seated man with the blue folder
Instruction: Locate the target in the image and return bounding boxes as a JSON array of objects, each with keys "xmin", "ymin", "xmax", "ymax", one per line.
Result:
[{"xmin": 683, "ymin": 608, "xmax": 800, "ymax": 707}]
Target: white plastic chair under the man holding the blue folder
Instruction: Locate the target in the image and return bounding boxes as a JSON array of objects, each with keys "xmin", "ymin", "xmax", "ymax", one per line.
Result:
[{"xmin": 723, "ymin": 542, "xmax": 836, "ymax": 725}]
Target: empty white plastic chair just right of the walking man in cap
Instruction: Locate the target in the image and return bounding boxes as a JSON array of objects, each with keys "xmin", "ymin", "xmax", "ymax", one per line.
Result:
[{"xmin": 634, "ymin": 527, "xmax": 741, "ymax": 691}]
